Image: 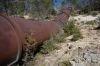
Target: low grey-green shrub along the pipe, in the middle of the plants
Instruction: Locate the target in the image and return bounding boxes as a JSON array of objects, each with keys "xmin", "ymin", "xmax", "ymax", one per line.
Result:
[{"xmin": 40, "ymin": 30, "xmax": 64, "ymax": 54}]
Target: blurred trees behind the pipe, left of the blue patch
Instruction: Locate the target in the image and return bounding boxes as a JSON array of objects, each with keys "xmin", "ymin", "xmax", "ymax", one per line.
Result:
[{"xmin": 0, "ymin": 0, "xmax": 54, "ymax": 17}]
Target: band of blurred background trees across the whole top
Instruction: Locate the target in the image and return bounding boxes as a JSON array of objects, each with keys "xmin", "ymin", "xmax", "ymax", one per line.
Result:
[{"xmin": 0, "ymin": 0, "xmax": 100, "ymax": 15}]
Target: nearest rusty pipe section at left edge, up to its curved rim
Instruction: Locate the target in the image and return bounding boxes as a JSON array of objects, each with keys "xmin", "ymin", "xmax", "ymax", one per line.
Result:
[{"xmin": 0, "ymin": 15, "xmax": 22, "ymax": 66}]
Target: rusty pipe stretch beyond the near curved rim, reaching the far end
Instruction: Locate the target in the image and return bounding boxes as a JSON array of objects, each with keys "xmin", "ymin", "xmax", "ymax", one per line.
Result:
[{"xmin": 10, "ymin": 8, "xmax": 71, "ymax": 43}]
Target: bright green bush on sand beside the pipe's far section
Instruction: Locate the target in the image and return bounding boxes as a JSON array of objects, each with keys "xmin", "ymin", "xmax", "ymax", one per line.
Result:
[{"xmin": 64, "ymin": 20, "xmax": 82, "ymax": 41}]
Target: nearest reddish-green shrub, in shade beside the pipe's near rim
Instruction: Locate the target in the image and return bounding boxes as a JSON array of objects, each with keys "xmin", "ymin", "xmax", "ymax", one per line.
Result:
[{"xmin": 16, "ymin": 33, "xmax": 36, "ymax": 66}]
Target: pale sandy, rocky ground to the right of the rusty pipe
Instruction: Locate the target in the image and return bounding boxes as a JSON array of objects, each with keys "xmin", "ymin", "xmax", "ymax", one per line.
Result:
[{"xmin": 34, "ymin": 16, "xmax": 100, "ymax": 66}]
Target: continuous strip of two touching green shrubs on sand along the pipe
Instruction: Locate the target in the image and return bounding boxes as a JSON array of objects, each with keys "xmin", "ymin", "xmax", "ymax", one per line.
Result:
[{"xmin": 35, "ymin": 20, "xmax": 82, "ymax": 54}]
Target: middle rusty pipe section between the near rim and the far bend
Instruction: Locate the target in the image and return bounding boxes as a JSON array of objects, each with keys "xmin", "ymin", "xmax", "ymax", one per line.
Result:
[{"xmin": 10, "ymin": 17, "xmax": 58, "ymax": 42}]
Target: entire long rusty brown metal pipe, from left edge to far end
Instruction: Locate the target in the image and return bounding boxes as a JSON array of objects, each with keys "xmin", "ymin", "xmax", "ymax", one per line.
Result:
[{"xmin": 0, "ymin": 9, "xmax": 71, "ymax": 66}]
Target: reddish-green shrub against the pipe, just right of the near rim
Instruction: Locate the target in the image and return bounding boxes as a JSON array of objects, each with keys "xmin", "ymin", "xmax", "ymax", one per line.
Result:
[{"xmin": 22, "ymin": 34, "xmax": 35, "ymax": 65}]
